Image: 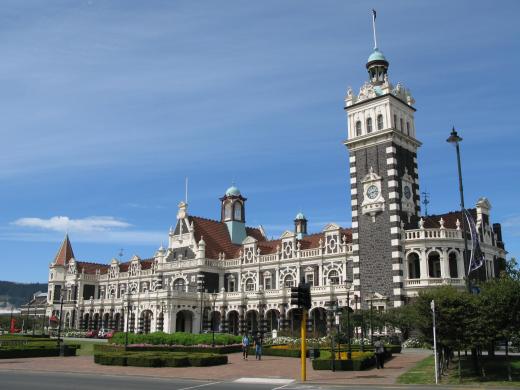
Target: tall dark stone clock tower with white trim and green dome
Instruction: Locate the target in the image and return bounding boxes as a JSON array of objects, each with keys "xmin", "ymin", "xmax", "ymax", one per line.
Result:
[{"xmin": 345, "ymin": 40, "xmax": 421, "ymax": 307}]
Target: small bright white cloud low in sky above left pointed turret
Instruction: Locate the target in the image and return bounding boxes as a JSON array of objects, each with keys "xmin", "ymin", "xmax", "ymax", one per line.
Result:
[{"xmin": 12, "ymin": 216, "xmax": 132, "ymax": 233}]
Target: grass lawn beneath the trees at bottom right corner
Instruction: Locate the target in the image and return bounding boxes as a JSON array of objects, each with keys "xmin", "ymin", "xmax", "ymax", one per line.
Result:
[{"xmin": 397, "ymin": 356, "xmax": 520, "ymax": 387}]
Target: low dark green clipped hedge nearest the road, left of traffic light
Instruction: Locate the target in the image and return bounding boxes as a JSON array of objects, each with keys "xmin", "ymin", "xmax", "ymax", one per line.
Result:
[{"xmin": 94, "ymin": 351, "xmax": 228, "ymax": 367}]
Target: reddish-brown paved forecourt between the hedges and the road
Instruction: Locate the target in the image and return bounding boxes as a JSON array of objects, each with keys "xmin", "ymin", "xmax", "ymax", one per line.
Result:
[{"xmin": 0, "ymin": 351, "xmax": 431, "ymax": 388}]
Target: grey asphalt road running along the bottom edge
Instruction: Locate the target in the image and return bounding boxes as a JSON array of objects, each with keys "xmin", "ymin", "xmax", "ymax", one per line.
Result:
[{"xmin": 0, "ymin": 371, "xmax": 504, "ymax": 390}]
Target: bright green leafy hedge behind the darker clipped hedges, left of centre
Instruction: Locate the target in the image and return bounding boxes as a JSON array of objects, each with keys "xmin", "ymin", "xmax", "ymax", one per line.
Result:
[{"xmin": 110, "ymin": 332, "xmax": 242, "ymax": 346}]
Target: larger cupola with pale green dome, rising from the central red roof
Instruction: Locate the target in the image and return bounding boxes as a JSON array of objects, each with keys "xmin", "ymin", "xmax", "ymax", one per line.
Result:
[{"xmin": 220, "ymin": 185, "xmax": 247, "ymax": 244}]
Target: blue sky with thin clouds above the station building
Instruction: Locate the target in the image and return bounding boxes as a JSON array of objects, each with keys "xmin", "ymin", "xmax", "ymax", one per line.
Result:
[{"xmin": 0, "ymin": 0, "xmax": 520, "ymax": 282}]
